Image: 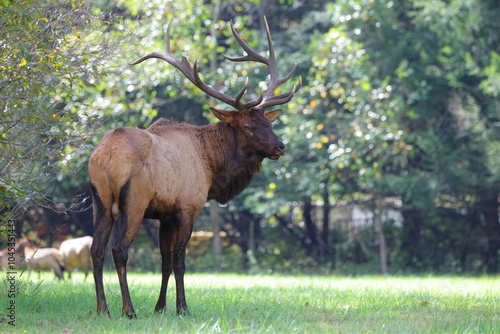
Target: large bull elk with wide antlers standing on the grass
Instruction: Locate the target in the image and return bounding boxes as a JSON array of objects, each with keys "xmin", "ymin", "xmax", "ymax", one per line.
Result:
[{"xmin": 89, "ymin": 16, "xmax": 301, "ymax": 318}]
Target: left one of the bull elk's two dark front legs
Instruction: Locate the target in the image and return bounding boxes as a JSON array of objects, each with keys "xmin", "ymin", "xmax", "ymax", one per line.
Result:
[{"xmin": 155, "ymin": 220, "xmax": 175, "ymax": 312}]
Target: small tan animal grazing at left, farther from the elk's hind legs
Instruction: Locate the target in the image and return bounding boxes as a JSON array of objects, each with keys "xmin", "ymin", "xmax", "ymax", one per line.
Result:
[{"xmin": 18, "ymin": 238, "xmax": 64, "ymax": 279}]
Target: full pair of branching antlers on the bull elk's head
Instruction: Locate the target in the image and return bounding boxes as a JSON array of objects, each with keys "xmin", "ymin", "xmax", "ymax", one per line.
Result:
[{"xmin": 130, "ymin": 17, "xmax": 302, "ymax": 111}]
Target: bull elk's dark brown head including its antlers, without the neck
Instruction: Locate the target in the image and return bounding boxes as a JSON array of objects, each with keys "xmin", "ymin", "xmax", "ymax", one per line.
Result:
[{"xmin": 131, "ymin": 17, "xmax": 301, "ymax": 160}]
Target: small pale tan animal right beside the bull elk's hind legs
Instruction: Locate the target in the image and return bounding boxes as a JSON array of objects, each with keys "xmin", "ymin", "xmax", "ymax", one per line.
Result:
[{"xmin": 59, "ymin": 236, "xmax": 92, "ymax": 278}]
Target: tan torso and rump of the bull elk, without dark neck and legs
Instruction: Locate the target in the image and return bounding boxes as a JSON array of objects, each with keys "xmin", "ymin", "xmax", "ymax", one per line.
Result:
[{"xmin": 89, "ymin": 120, "xmax": 212, "ymax": 227}]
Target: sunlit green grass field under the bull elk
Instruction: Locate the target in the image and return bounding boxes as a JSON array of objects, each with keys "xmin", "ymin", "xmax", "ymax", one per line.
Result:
[{"xmin": 0, "ymin": 272, "xmax": 500, "ymax": 333}]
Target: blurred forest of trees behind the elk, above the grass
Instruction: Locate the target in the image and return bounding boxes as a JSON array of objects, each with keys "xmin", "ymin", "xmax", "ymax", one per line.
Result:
[{"xmin": 0, "ymin": 0, "xmax": 500, "ymax": 274}]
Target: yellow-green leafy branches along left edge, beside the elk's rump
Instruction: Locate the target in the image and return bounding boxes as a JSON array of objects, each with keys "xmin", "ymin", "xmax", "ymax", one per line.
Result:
[{"xmin": 0, "ymin": 0, "xmax": 125, "ymax": 231}]
